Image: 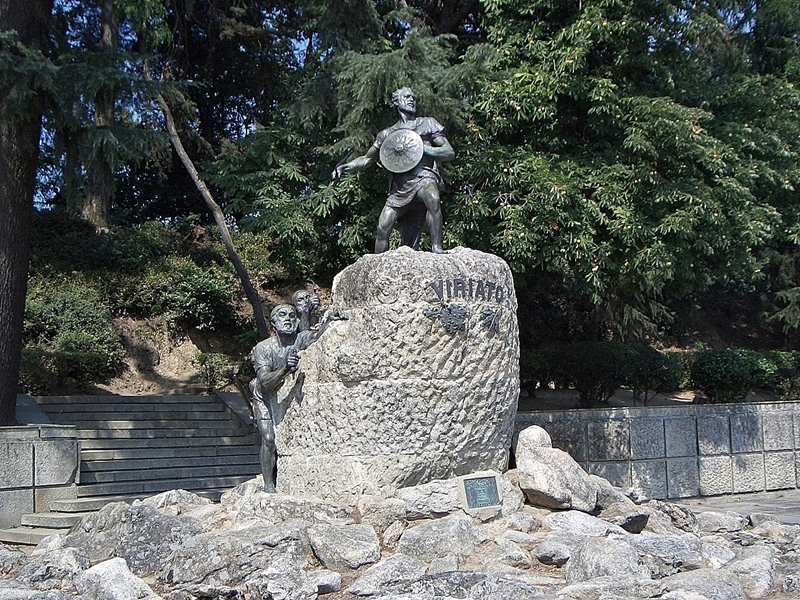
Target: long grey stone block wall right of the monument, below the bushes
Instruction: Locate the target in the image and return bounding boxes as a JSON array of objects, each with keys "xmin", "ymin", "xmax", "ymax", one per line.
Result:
[{"xmin": 516, "ymin": 402, "xmax": 800, "ymax": 499}]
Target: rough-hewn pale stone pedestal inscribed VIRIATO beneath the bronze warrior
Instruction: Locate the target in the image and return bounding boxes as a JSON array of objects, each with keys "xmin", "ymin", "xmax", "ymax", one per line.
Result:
[{"xmin": 275, "ymin": 247, "xmax": 519, "ymax": 501}]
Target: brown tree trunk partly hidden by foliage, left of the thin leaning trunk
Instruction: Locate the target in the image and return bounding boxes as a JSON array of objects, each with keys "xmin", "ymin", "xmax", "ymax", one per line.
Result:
[{"xmin": 81, "ymin": 0, "xmax": 119, "ymax": 229}]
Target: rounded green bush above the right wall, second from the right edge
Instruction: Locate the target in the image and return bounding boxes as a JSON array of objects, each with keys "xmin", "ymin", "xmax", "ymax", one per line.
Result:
[{"xmin": 692, "ymin": 348, "xmax": 773, "ymax": 402}]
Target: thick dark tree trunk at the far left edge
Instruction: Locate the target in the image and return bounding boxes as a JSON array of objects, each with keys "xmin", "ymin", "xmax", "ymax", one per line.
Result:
[{"xmin": 0, "ymin": 0, "xmax": 53, "ymax": 426}]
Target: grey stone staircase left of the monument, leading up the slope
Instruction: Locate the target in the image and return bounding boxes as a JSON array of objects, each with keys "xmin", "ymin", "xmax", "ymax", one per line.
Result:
[{"xmin": 0, "ymin": 394, "xmax": 261, "ymax": 544}]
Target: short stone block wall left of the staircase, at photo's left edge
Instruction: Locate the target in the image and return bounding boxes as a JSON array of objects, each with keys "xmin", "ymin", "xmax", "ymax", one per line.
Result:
[{"xmin": 0, "ymin": 425, "xmax": 80, "ymax": 528}]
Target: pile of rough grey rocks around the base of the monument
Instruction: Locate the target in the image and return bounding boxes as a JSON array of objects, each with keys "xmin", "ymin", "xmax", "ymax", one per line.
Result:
[{"xmin": 0, "ymin": 428, "xmax": 800, "ymax": 600}]
